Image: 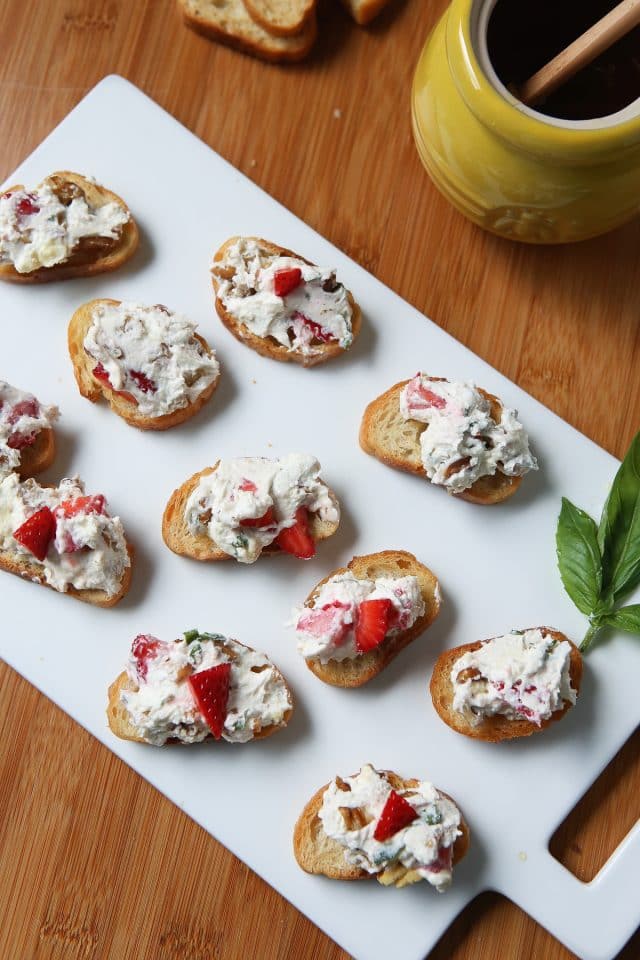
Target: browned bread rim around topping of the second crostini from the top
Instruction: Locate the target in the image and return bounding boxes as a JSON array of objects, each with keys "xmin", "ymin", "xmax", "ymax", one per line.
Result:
[{"xmin": 211, "ymin": 237, "xmax": 362, "ymax": 367}]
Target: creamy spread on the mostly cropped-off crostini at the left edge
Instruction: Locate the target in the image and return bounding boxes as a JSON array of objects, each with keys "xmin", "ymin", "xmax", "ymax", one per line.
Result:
[{"xmin": 0, "ymin": 380, "xmax": 59, "ymax": 477}]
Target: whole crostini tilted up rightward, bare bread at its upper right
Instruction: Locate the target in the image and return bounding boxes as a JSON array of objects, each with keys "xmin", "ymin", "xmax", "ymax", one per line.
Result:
[{"xmin": 292, "ymin": 550, "xmax": 440, "ymax": 687}]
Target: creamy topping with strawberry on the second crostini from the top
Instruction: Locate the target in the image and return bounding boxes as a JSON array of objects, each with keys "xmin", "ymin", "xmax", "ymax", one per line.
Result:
[{"xmin": 213, "ymin": 238, "xmax": 353, "ymax": 354}]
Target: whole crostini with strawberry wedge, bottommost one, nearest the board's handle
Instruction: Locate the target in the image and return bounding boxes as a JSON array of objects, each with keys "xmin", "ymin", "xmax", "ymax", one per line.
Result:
[{"xmin": 293, "ymin": 764, "xmax": 469, "ymax": 893}]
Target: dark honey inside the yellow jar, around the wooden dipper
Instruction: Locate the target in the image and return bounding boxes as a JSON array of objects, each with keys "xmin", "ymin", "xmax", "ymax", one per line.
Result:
[{"xmin": 487, "ymin": 0, "xmax": 640, "ymax": 120}]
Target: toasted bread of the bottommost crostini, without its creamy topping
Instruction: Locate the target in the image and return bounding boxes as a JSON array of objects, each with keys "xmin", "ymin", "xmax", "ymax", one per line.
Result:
[{"xmin": 293, "ymin": 770, "xmax": 470, "ymax": 885}]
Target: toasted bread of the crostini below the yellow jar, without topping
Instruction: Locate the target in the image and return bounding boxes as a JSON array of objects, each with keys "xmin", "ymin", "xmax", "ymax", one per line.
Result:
[{"xmin": 360, "ymin": 377, "xmax": 522, "ymax": 505}]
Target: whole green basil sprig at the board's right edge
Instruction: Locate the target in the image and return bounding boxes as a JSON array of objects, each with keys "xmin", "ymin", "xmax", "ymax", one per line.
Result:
[{"xmin": 556, "ymin": 433, "xmax": 640, "ymax": 650}]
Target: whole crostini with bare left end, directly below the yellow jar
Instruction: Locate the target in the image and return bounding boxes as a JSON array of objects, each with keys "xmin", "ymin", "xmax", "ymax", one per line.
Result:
[{"xmin": 360, "ymin": 373, "xmax": 537, "ymax": 505}]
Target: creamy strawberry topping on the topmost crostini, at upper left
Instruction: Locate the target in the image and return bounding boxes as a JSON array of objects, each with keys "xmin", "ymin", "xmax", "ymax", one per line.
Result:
[{"xmin": 0, "ymin": 176, "xmax": 130, "ymax": 273}]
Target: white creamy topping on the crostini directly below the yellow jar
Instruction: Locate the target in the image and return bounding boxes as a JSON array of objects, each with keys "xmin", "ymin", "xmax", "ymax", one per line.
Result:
[{"xmin": 400, "ymin": 373, "xmax": 537, "ymax": 493}]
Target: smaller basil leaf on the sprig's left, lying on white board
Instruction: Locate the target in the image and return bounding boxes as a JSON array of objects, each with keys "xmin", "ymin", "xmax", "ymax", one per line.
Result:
[{"xmin": 556, "ymin": 497, "xmax": 602, "ymax": 615}]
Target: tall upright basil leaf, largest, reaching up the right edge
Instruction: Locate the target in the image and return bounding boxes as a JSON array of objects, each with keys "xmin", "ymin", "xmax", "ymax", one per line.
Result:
[{"xmin": 598, "ymin": 433, "xmax": 640, "ymax": 601}]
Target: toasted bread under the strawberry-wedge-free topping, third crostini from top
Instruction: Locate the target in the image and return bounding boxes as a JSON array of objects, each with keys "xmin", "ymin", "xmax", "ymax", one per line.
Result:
[{"xmin": 67, "ymin": 298, "xmax": 220, "ymax": 430}]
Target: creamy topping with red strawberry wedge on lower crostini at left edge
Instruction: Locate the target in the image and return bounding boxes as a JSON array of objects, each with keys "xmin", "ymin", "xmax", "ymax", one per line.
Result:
[{"xmin": 0, "ymin": 473, "xmax": 130, "ymax": 596}]
